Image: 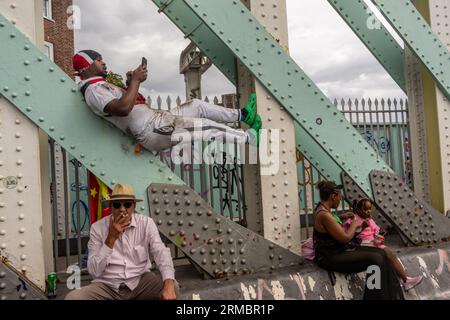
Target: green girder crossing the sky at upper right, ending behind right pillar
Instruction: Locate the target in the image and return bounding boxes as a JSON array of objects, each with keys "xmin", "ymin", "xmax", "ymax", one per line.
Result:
[{"xmin": 327, "ymin": 0, "xmax": 406, "ymax": 92}]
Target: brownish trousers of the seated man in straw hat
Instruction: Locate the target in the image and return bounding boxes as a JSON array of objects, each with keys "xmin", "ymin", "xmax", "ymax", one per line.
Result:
[{"xmin": 65, "ymin": 272, "xmax": 179, "ymax": 300}]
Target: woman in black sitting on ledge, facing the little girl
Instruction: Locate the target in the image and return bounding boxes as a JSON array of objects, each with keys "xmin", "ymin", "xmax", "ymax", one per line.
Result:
[{"xmin": 313, "ymin": 181, "xmax": 403, "ymax": 300}]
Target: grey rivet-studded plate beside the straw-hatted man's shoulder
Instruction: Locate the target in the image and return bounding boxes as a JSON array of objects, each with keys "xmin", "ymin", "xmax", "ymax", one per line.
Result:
[{"xmin": 148, "ymin": 184, "xmax": 303, "ymax": 278}]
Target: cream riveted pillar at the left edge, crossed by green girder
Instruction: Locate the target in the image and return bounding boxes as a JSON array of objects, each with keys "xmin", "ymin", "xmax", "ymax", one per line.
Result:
[{"xmin": 0, "ymin": 0, "xmax": 53, "ymax": 290}]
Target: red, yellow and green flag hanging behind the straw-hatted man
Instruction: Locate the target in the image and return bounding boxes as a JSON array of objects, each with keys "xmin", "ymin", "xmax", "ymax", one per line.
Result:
[{"xmin": 88, "ymin": 172, "xmax": 111, "ymax": 225}]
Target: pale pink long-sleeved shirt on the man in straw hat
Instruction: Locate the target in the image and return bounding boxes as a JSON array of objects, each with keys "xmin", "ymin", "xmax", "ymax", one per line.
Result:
[{"xmin": 88, "ymin": 213, "xmax": 175, "ymax": 291}]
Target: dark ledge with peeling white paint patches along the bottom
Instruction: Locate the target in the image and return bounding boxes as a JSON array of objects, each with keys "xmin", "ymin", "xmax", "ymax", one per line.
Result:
[{"xmin": 177, "ymin": 243, "xmax": 450, "ymax": 300}]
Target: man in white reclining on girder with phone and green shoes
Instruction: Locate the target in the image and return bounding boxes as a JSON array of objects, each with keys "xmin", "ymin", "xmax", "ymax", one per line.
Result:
[{"xmin": 73, "ymin": 50, "xmax": 261, "ymax": 151}]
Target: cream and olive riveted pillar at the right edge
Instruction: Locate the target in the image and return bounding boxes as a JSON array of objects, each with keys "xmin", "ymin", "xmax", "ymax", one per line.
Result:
[{"xmin": 407, "ymin": 0, "xmax": 450, "ymax": 212}]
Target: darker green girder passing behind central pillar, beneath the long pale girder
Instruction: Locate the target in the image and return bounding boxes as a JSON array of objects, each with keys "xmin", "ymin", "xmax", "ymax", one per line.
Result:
[{"xmin": 153, "ymin": 0, "xmax": 342, "ymax": 181}]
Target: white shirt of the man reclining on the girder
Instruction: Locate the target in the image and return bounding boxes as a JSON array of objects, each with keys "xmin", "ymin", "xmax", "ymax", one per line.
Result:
[{"xmin": 78, "ymin": 77, "xmax": 152, "ymax": 137}]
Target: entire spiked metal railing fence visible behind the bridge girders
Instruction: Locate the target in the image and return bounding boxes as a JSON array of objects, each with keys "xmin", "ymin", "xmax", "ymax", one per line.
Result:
[{"xmin": 50, "ymin": 95, "xmax": 412, "ymax": 272}]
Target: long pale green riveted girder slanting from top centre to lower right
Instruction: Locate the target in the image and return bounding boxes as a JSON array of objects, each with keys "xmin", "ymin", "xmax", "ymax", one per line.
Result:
[{"xmin": 174, "ymin": 0, "xmax": 391, "ymax": 197}]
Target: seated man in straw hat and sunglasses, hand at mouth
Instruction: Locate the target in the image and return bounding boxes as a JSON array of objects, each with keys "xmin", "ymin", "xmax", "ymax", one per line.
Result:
[{"xmin": 66, "ymin": 184, "xmax": 178, "ymax": 300}]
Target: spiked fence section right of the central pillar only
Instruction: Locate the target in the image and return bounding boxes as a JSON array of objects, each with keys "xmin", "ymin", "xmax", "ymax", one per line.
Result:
[{"xmin": 297, "ymin": 99, "xmax": 413, "ymax": 239}]
